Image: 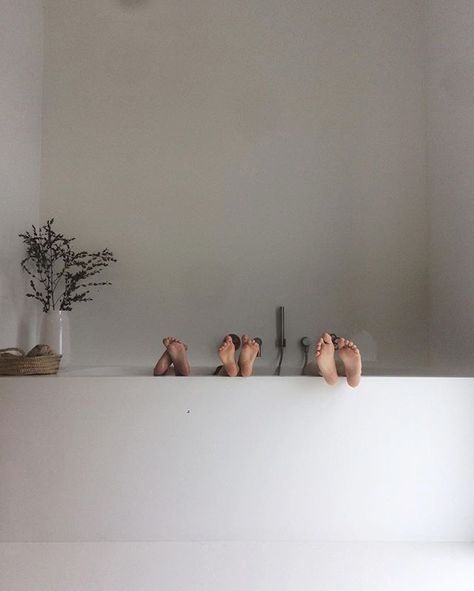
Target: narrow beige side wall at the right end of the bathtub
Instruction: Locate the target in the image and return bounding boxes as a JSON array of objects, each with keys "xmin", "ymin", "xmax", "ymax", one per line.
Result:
[{"xmin": 427, "ymin": 0, "xmax": 474, "ymax": 368}]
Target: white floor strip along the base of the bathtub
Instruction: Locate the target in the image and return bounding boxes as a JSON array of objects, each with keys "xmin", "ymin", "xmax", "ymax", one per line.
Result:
[{"xmin": 0, "ymin": 542, "xmax": 474, "ymax": 591}]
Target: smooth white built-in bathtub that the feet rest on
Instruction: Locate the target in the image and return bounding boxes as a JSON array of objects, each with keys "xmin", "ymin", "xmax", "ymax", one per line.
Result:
[{"xmin": 0, "ymin": 368, "xmax": 474, "ymax": 591}]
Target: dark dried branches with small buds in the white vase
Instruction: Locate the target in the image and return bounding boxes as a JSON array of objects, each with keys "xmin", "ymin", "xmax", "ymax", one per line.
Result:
[{"xmin": 19, "ymin": 218, "xmax": 117, "ymax": 312}]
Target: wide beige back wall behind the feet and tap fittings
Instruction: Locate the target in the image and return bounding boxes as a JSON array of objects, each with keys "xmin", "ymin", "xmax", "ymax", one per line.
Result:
[{"xmin": 41, "ymin": 0, "xmax": 428, "ymax": 365}]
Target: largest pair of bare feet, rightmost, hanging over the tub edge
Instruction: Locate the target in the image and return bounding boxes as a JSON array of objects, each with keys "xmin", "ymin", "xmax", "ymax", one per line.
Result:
[{"xmin": 315, "ymin": 332, "xmax": 362, "ymax": 388}]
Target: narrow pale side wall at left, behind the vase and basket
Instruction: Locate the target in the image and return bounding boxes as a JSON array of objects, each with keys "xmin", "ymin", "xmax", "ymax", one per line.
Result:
[{"xmin": 0, "ymin": 0, "xmax": 43, "ymax": 348}]
